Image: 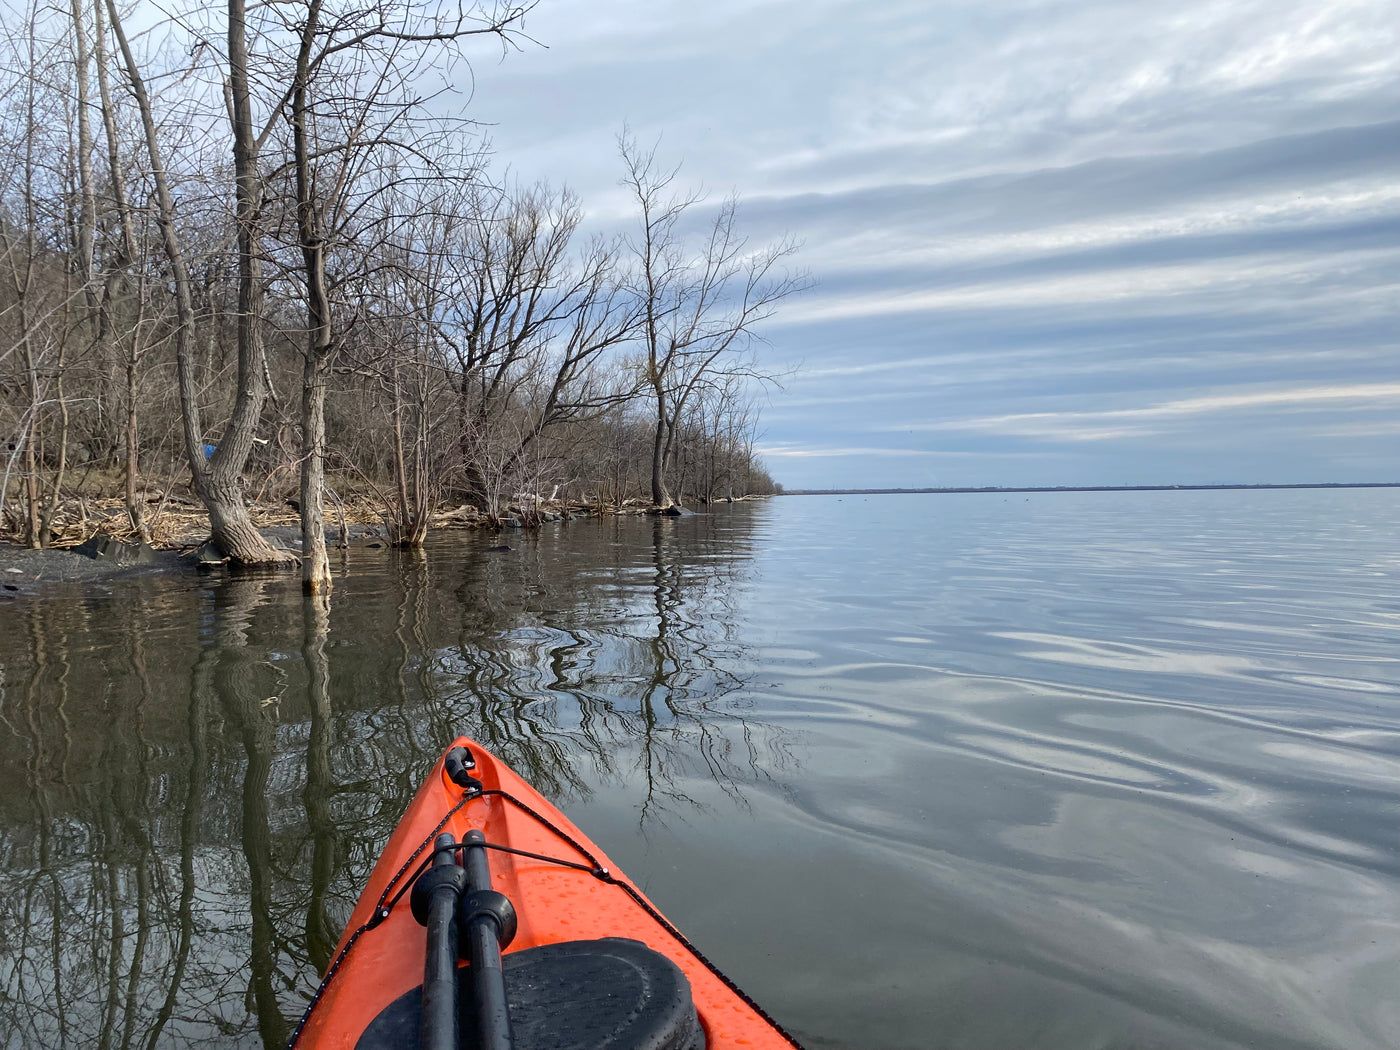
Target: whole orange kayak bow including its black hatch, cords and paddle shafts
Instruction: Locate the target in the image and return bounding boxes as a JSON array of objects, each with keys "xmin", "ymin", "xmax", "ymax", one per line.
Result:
[{"xmin": 288, "ymin": 736, "xmax": 799, "ymax": 1050}]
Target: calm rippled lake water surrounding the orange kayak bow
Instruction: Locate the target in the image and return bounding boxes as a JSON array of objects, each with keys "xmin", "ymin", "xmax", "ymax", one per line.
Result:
[{"xmin": 0, "ymin": 490, "xmax": 1400, "ymax": 1050}]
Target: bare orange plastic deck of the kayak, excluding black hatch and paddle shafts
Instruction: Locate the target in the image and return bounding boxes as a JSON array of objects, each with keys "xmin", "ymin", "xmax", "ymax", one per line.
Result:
[{"xmin": 293, "ymin": 736, "xmax": 798, "ymax": 1050}]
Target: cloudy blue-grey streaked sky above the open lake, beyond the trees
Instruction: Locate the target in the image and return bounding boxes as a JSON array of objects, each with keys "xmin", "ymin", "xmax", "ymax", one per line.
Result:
[{"xmin": 456, "ymin": 0, "xmax": 1400, "ymax": 487}]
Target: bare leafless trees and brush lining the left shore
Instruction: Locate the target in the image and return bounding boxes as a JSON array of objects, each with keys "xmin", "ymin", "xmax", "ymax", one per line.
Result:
[{"xmin": 0, "ymin": 0, "xmax": 805, "ymax": 591}]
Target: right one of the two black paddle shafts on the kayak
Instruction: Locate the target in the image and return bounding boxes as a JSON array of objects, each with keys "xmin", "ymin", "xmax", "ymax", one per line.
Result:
[{"xmin": 459, "ymin": 830, "xmax": 515, "ymax": 1050}]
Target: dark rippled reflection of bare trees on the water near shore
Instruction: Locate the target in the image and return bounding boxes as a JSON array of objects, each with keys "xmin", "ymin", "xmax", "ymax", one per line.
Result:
[{"xmin": 0, "ymin": 506, "xmax": 784, "ymax": 1050}]
